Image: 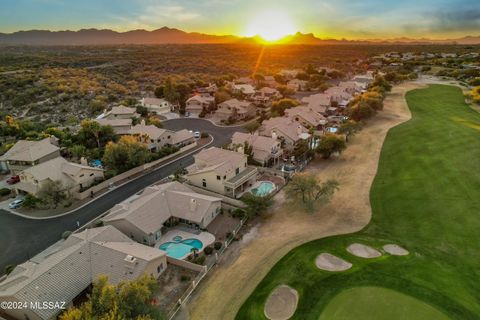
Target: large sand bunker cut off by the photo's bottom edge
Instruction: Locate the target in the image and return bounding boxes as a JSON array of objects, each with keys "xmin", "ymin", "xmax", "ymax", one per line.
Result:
[{"xmin": 263, "ymin": 285, "xmax": 298, "ymax": 320}]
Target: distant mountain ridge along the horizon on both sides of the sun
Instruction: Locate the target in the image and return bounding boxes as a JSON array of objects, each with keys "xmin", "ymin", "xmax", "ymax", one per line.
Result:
[{"xmin": 0, "ymin": 27, "xmax": 480, "ymax": 46}]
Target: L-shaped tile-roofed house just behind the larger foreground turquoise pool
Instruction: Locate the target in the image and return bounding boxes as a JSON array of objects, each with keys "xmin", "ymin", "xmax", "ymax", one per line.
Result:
[{"xmin": 103, "ymin": 181, "xmax": 221, "ymax": 245}]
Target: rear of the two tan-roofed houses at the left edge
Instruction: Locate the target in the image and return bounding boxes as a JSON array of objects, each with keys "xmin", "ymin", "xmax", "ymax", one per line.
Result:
[{"xmin": 0, "ymin": 137, "xmax": 60, "ymax": 175}]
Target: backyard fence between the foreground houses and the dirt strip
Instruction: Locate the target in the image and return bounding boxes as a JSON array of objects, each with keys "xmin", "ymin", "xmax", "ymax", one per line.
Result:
[{"xmin": 167, "ymin": 219, "xmax": 246, "ymax": 320}]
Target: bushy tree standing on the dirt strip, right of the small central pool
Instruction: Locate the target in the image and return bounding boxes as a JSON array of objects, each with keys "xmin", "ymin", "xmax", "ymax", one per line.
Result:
[{"xmin": 285, "ymin": 173, "xmax": 338, "ymax": 212}]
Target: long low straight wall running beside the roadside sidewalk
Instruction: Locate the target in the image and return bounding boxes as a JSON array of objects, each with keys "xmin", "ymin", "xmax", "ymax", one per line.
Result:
[{"xmin": 73, "ymin": 142, "xmax": 197, "ymax": 200}]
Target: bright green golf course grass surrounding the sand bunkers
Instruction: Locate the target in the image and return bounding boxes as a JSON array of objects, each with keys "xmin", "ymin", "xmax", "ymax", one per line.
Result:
[{"xmin": 237, "ymin": 85, "xmax": 480, "ymax": 320}]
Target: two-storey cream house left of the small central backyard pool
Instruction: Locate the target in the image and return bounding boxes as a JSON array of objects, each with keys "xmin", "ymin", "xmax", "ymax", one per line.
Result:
[{"xmin": 186, "ymin": 147, "xmax": 258, "ymax": 198}]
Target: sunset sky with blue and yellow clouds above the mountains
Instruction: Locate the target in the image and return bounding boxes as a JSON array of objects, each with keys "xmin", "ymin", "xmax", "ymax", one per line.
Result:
[{"xmin": 0, "ymin": 0, "xmax": 480, "ymax": 39}]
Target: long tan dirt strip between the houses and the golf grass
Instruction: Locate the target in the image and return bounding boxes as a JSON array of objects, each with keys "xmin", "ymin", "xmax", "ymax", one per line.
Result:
[{"xmin": 189, "ymin": 83, "xmax": 423, "ymax": 320}]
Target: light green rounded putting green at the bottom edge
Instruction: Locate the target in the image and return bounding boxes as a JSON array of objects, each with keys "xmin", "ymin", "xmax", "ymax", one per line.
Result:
[{"xmin": 319, "ymin": 287, "xmax": 449, "ymax": 320}]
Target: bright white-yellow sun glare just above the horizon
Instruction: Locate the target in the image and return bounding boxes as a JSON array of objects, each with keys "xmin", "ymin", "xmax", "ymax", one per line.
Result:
[{"xmin": 245, "ymin": 11, "xmax": 296, "ymax": 42}]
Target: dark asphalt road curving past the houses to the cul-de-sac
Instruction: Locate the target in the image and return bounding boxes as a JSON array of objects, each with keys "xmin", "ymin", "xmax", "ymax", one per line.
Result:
[{"xmin": 0, "ymin": 118, "xmax": 245, "ymax": 275}]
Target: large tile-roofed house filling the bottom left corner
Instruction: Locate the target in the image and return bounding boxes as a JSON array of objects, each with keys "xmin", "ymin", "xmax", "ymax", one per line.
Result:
[{"xmin": 0, "ymin": 226, "xmax": 167, "ymax": 320}]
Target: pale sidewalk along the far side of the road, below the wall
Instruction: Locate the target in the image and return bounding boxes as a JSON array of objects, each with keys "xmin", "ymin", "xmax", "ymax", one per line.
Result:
[{"xmin": 7, "ymin": 136, "xmax": 214, "ymax": 220}]
